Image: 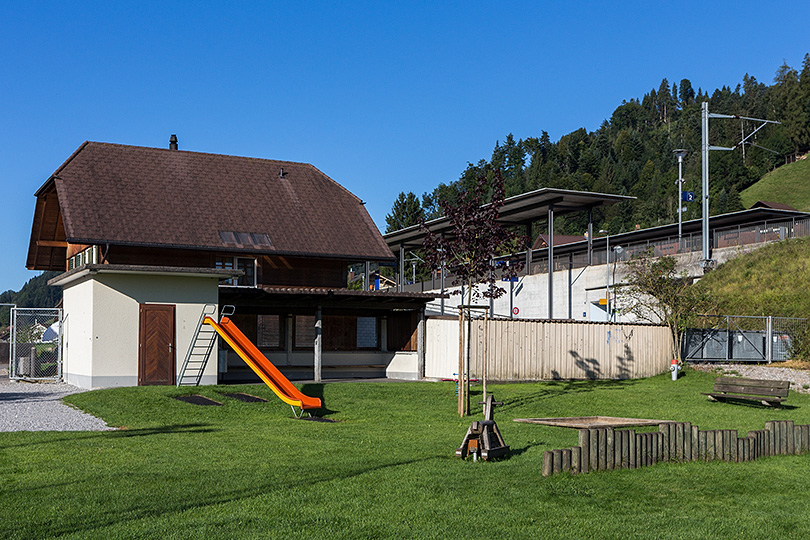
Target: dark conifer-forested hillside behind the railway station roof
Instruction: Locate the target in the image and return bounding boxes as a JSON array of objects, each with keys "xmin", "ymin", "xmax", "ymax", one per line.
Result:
[{"xmin": 386, "ymin": 54, "xmax": 810, "ymax": 234}]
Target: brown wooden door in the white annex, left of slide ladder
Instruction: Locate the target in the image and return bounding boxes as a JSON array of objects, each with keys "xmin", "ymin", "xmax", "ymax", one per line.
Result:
[{"xmin": 138, "ymin": 304, "xmax": 175, "ymax": 386}]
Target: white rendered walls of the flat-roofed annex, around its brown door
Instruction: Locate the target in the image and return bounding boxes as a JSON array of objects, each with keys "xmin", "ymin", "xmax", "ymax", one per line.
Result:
[{"xmin": 63, "ymin": 273, "xmax": 219, "ymax": 388}]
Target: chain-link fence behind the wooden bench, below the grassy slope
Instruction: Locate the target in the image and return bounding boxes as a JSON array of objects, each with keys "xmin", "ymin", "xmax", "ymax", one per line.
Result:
[{"xmin": 683, "ymin": 315, "xmax": 807, "ymax": 362}]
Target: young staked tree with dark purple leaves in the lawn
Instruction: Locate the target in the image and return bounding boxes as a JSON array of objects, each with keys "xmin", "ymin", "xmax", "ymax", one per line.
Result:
[{"xmin": 422, "ymin": 169, "xmax": 525, "ymax": 415}]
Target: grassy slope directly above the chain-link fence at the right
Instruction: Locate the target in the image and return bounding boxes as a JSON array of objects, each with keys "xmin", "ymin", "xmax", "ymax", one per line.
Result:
[{"xmin": 699, "ymin": 235, "xmax": 810, "ymax": 318}]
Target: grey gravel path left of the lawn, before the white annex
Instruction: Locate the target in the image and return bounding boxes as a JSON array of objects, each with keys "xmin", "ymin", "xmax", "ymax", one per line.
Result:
[{"xmin": 0, "ymin": 371, "xmax": 113, "ymax": 431}]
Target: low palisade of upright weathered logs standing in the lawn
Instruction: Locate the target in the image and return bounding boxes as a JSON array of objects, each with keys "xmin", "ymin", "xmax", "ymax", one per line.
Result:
[{"xmin": 542, "ymin": 420, "xmax": 810, "ymax": 476}]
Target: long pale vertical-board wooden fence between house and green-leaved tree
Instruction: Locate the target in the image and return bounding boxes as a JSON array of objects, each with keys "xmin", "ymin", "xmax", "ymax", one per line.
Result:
[{"xmin": 425, "ymin": 317, "xmax": 672, "ymax": 381}]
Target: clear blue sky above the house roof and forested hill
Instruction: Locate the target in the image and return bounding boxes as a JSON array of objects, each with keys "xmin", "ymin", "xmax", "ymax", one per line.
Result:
[{"xmin": 0, "ymin": 0, "xmax": 810, "ymax": 290}]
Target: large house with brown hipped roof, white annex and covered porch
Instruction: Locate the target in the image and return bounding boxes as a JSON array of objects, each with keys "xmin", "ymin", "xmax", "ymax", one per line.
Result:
[{"xmin": 26, "ymin": 137, "xmax": 436, "ymax": 388}]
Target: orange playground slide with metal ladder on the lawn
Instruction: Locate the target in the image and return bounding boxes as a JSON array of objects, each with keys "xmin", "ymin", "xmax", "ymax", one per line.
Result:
[{"xmin": 177, "ymin": 306, "xmax": 321, "ymax": 417}]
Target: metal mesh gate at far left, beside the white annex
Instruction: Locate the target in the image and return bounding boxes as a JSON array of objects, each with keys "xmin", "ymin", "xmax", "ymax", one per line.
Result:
[{"xmin": 9, "ymin": 308, "xmax": 62, "ymax": 381}]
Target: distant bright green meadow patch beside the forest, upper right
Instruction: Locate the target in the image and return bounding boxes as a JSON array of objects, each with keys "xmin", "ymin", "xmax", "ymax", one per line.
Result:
[{"xmin": 740, "ymin": 158, "xmax": 810, "ymax": 212}]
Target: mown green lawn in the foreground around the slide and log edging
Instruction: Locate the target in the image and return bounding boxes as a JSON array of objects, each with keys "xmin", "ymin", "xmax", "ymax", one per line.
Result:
[{"xmin": 0, "ymin": 370, "xmax": 810, "ymax": 540}]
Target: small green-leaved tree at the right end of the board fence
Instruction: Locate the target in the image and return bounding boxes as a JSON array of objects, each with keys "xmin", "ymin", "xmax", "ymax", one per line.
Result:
[{"xmin": 619, "ymin": 250, "xmax": 714, "ymax": 364}]
